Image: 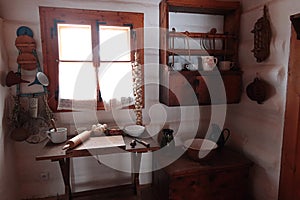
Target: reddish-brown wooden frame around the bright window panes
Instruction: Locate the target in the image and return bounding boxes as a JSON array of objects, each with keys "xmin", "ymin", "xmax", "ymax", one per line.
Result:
[{"xmin": 39, "ymin": 7, "xmax": 144, "ymax": 112}]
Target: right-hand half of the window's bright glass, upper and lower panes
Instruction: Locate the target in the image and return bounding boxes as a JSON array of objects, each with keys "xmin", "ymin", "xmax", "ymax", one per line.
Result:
[{"xmin": 98, "ymin": 26, "xmax": 133, "ymax": 102}]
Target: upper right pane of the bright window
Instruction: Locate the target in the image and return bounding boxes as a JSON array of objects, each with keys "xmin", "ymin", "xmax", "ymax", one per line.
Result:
[{"xmin": 99, "ymin": 26, "xmax": 130, "ymax": 61}]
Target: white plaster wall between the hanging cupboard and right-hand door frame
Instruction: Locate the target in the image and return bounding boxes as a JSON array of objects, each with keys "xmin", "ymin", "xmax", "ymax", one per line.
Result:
[{"xmin": 226, "ymin": 0, "xmax": 300, "ymax": 200}]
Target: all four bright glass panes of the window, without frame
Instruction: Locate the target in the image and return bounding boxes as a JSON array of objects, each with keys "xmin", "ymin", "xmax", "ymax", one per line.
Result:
[{"xmin": 58, "ymin": 24, "xmax": 133, "ymax": 109}]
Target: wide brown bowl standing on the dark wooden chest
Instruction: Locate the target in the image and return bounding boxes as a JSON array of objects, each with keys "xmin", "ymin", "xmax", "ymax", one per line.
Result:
[{"xmin": 184, "ymin": 138, "xmax": 218, "ymax": 161}]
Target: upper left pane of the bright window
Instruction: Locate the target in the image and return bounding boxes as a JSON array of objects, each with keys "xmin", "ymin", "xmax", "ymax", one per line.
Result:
[{"xmin": 57, "ymin": 24, "xmax": 92, "ymax": 61}]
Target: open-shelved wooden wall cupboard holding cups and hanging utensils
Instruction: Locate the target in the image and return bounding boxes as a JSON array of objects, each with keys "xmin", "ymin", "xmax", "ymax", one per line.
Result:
[{"xmin": 159, "ymin": 0, "xmax": 242, "ymax": 106}]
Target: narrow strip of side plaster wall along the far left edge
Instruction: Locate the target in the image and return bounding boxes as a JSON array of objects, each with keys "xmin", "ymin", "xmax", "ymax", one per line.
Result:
[{"xmin": 0, "ymin": 18, "xmax": 18, "ymax": 200}]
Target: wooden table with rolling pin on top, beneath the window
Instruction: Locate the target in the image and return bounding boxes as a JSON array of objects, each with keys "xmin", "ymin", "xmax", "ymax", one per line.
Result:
[{"xmin": 36, "ymin": 133, "xmax": 160, "ymax": 199}]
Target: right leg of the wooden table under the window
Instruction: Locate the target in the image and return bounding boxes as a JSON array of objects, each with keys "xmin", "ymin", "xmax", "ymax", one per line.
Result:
[{"xmin": 131, "ymin": 153, "xmax": 142, "ymax": 199}]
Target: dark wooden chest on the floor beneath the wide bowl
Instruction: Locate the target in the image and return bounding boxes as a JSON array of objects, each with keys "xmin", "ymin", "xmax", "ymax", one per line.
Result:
[{"xmin": 153, "ymin": 148, "xmax": 251, "ymax": 200}]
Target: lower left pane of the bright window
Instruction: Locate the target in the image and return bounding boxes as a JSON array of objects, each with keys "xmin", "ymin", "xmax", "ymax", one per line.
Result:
[{"xmin": 59, "ymin": 62, "xmax": 97, "ymax": 100}]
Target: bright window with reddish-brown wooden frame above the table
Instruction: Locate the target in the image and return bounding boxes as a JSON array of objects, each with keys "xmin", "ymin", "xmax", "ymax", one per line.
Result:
[{"xmin": 40, "ymin": 7, "xmax": 144, "ymax": 111}]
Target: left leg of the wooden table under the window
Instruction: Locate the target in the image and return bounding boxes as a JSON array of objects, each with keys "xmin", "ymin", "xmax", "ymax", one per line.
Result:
[{"xmin": 58, "ymin": 158, "xmax": 72, "ymax": 200}]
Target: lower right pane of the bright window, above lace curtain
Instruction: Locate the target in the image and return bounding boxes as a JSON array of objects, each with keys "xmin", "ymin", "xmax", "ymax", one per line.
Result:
[{"xmin": 98, "ymin": 62, "xmax": 133, "ymax": 101}]
